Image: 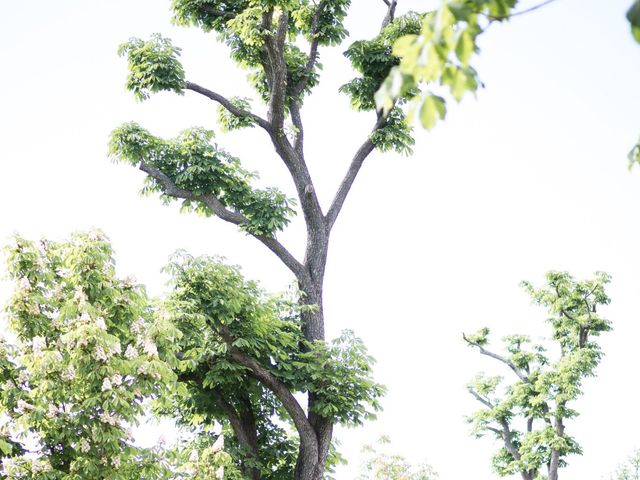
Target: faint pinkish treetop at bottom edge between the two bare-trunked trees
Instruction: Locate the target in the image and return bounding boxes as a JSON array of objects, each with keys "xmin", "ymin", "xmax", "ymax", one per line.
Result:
[{"xmin": 358, "ymin": 437, "xmax": 438, "ymax": 480}]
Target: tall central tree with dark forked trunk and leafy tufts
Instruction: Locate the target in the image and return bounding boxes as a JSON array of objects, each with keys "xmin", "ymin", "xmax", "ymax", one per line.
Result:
[{"xmin": 110, "ymin": 0, "xmax": 424, "ymax": 480}]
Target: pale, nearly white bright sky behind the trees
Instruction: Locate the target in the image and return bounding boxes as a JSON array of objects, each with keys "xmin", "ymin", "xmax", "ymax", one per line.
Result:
[{"xmin": 0, "ymin": 0, "xmax": 640, "ymax": 480}]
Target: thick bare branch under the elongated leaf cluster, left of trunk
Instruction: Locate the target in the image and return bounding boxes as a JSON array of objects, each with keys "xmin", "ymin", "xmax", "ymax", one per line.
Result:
[{"xmin": 140, "ymin": 162, "xmax": 304, "ymax": 277}]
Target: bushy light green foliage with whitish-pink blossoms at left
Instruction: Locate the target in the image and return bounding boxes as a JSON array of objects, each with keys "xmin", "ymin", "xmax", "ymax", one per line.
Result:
[{"xmin": 0, "ymin": 232, "xmax": 179, "ymax": 480}]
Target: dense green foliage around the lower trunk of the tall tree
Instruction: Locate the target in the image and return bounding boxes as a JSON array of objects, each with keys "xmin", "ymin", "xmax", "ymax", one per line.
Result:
[{"xmin": 160, "ymin": 254, "xmax": 383, "ymax": 480}]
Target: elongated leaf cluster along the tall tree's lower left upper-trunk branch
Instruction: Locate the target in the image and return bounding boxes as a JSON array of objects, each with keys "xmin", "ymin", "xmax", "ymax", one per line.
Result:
[{"xmin": 109, "ymin": 123, "xmax": 295, "ymax": 236}]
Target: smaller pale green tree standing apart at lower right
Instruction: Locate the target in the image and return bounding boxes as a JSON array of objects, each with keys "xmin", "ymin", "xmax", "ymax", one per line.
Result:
[{"xmin": 463, "ymin": 272, "xmax": 611, "ymax": 480}]
